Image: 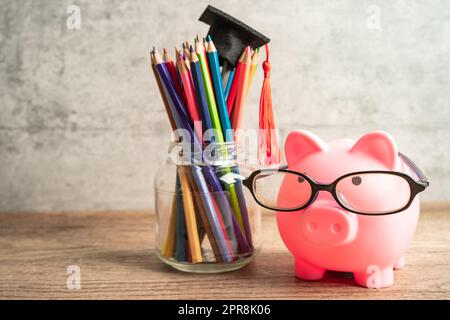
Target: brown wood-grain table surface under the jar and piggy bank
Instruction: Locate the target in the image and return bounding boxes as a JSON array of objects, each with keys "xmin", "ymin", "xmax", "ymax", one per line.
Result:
[{"xmin": 0, "ymin": 203, "xmax": 450, "ymax": 299}]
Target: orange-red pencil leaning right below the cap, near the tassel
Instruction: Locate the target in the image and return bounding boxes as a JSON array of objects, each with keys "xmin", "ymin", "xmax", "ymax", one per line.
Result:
[{"xmin": 231, "ymin": 47, "xmax": 251, "ymax": 130}]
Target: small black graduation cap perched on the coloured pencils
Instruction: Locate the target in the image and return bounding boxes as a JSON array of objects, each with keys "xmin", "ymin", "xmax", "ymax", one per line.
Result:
[{"xmin": 199, "ymin": 6, "xmax": 270, "ymax": 67}]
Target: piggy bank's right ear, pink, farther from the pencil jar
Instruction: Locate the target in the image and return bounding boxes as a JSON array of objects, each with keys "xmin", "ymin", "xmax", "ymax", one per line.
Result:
[{"xmin": 350, "ymin": 131, "xmax": 398, "ymax": 170}]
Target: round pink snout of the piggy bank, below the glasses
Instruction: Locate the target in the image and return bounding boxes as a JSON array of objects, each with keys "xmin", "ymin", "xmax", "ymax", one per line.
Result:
[{"xmin": 300, "ymin": 206, "xmax": 358, "ymax": 246}]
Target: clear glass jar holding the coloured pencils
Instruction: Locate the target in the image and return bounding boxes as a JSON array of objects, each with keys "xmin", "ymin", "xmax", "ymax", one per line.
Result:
[{"xmin": 154, "ymin": 143, "xmax": 261, "ymax": 273}]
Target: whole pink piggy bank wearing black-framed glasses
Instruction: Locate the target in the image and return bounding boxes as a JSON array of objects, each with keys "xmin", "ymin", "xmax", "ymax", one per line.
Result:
[{"xmin": 277, "ymin": 131, "xmax": 428, "ymax": 288}]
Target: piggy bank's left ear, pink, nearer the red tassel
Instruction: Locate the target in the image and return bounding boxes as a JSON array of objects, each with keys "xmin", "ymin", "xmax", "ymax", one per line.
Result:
[{"xmin": 284, "ymin": 130, "xmax": 328, "ymax": 165}]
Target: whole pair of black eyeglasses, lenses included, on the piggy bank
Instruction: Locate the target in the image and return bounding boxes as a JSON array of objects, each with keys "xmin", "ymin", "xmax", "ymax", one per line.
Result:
[{"xmin": 243, "ymin": 153, "xmax": 429, "ymax": 215}]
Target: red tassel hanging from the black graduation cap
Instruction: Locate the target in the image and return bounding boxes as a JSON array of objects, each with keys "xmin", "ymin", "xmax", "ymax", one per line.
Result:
[{"xmin": 258, "ymin": 44, "xmax": 281, "ymax": 166}]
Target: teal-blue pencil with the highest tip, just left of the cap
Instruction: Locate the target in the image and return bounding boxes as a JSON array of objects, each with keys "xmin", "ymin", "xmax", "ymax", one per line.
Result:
[{"xmin": 206, "ymin": 35, "xmax": 233, "ymax": 142}]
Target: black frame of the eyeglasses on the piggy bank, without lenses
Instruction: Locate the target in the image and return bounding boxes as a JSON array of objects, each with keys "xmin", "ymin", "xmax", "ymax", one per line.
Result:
[{"xmin": 242, "ymin": 152, "xmax": 430, "ymax": 216}]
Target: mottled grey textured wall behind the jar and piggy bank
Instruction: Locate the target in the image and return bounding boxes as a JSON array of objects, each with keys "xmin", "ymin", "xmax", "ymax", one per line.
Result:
[{"xmin": 0, "ymin": 0, "xmax": 450, "ymax": 211}]
